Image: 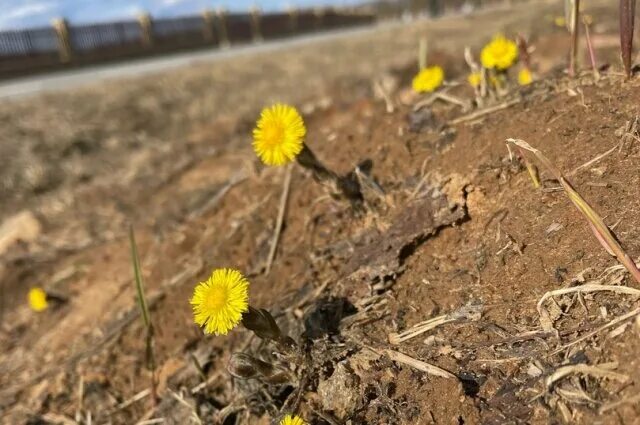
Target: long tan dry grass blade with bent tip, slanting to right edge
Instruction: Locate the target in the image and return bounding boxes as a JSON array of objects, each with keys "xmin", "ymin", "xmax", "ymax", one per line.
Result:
[{"xmin": 507, "ymin": 139, "xmax": 640, "ymax": 283}]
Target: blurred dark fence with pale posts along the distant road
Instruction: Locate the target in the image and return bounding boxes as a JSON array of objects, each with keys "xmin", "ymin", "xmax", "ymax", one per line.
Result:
[{"xmin": 0, "ymin": 10, "xmax": 375, "ymax": 78}]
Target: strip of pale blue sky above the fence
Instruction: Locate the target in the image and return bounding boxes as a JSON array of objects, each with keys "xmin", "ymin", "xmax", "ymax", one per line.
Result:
[{"xmin": 0, "ymin": 0, "xmax": 362, "ymax": 30}]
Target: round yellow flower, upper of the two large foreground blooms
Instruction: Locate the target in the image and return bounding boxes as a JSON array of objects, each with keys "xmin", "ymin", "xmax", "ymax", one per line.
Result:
[{"xmin": 253, "ymin": 103, "xmax": 307, "ymax": 165}]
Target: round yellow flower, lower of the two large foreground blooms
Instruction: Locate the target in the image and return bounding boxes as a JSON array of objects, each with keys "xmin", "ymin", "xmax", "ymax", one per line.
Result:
[{"xmin": 191, "ymin": 269, "xmax": 249, "ymax": 335}]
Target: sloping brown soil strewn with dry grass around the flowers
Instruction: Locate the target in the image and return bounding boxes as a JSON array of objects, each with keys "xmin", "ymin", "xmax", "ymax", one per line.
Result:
[{"xmin": 0, "ymin": 4, "xmax": 640, "ymax": 424}]
